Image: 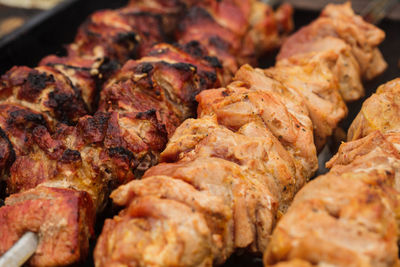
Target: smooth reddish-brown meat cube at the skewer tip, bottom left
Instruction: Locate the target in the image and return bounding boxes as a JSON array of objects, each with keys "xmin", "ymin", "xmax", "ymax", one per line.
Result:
[{"xmin": 0, "ymin": 187, "xmax": 94, "ymax": 266}]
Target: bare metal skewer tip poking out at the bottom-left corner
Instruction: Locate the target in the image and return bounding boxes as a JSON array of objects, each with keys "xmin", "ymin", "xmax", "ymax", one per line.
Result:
[{"xmin": 0, "ymin": 232, "xmax": 38, "ymax": 267}]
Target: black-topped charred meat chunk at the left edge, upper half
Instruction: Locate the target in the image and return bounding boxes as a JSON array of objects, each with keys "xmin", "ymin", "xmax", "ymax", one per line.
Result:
[{"xmin": 0, "ymin": 66, "xmax": 87, "ymax": 125}]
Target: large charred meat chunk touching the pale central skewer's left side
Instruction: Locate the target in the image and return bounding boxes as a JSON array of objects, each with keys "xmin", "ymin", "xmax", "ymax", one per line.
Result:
[{"xmin": 91, "ymin": 43, "xmax": 220, "ymax": 184}]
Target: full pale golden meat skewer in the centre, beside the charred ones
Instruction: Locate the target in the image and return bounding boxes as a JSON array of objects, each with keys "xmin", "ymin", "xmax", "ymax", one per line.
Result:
[{"xmin": 94, "ymin": 4, "xmax": 386, "ymax": 267}]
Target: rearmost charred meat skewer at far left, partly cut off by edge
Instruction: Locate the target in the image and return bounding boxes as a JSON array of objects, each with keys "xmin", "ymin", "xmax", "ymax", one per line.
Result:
[{"xmin": 0, "ymin": 3, "xmax": 169, "ymax": 194}]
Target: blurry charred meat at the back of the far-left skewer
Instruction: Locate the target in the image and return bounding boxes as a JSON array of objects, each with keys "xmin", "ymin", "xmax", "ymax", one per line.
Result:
[{"xmin": 39, "ymin": 9, "xmax": 164, "ymax": 110}]
